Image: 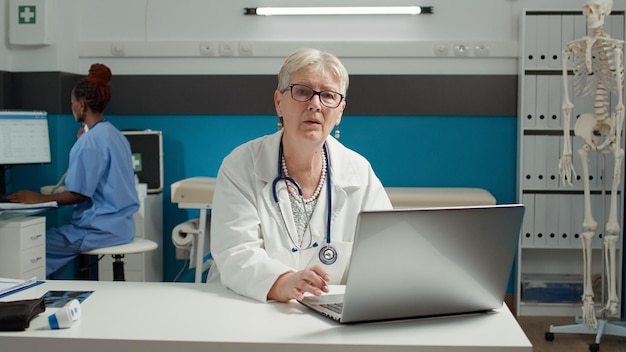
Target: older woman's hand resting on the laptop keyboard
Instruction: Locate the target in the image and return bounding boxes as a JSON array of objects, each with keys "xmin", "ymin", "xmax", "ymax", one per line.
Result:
[{"xmin": 267, "ymin": 265, "xmax": 330, "ymax": 302}]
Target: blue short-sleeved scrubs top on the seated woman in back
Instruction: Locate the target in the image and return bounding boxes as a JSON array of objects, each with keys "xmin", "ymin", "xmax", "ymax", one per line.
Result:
[{"xmin": 58, "ymin": 121, "xmax": 139, "ymax": 251}]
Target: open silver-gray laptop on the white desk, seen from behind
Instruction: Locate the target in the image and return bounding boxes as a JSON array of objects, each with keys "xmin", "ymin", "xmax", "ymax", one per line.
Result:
[{"xmin": 300, "ymin": 204, "xmax": 524, "ymax": 323}]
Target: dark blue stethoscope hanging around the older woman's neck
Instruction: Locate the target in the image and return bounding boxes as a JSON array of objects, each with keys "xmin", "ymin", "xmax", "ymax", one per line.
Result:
[{"xmin": 272, "ymin": 142, "xmax": 337, "ymax": 265}]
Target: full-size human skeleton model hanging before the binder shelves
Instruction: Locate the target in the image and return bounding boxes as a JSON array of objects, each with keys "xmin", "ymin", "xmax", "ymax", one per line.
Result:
[{"xmin": 559, "ymin": 0, "xmax": 624, "ymax": 329}]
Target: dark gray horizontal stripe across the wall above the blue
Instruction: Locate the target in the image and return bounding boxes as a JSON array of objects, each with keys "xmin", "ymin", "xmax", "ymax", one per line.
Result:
[{"xmin": 0, "ymin": 72, "xmax": 517, "ymax": 116}]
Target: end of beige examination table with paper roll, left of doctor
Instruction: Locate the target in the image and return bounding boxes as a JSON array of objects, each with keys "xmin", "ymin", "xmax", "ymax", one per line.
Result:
[{"xmin": 171, "ymin": 176, "xmax": 216, "ymax": 282}]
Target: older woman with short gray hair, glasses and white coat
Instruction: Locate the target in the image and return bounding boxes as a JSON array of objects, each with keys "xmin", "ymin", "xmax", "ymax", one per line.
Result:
[{"xmin": 207, "ymin": 48, "xmax": 391, "ymax": 302}]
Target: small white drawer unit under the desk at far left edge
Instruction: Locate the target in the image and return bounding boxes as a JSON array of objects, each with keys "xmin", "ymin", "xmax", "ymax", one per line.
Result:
[{"xmin": 0, "ymin": 216, "xmax": 46, "ymax": 280}]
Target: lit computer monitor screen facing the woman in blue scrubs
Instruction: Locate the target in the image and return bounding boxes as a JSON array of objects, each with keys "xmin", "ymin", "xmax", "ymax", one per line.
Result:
[{"xmin": 0, "ymin": 110, "xmax": 51, "ymax": 165}]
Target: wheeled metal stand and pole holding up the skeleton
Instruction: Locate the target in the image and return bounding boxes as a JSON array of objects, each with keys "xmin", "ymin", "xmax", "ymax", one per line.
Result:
[{"xmin": 545, "ymin": 154, "xmax": 626, "ymax": 352}]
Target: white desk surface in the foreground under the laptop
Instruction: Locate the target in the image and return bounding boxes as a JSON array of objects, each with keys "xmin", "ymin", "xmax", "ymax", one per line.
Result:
[{"xmin": 0, "ymin": 281, "xmax": 532, "ymax": 352}]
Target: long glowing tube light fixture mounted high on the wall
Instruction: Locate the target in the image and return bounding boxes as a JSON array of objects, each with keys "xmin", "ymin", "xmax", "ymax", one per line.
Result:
[{"xmin": 244, "ymin": 6, "xmax": 434, "ymax": 16}]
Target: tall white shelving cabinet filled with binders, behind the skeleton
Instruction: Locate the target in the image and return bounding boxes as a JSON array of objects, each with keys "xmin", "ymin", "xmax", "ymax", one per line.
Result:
[{"xmin": 516, "ymin": 8, "xmax": 624, "ymax": 316}]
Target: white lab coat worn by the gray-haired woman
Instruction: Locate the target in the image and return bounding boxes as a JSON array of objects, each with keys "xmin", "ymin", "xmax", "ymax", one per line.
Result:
[{"xmin": 207, "ymin": 131, "xmax": 392, "ymax": 301}]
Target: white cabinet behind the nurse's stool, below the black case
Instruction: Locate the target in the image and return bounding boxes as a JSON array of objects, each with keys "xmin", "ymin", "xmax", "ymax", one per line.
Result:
[{"xmin": 98, "ymin": 183, "xmax": 163, "ymax": 282}]
